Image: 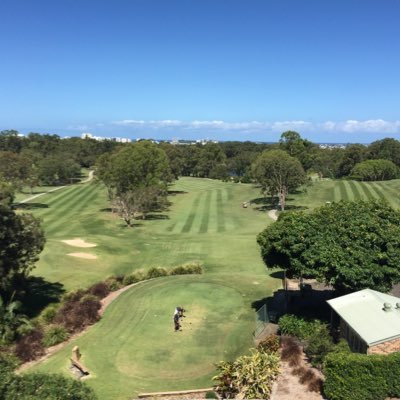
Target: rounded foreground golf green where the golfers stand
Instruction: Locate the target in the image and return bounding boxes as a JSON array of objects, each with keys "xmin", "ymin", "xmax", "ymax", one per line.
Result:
[{"xmin": 32, "ymin": 276, "xmax": 254, "ymax": 399}]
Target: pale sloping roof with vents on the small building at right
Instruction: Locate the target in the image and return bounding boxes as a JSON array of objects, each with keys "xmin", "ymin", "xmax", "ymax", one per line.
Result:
[{"xmin": 328, "ymin": 289, "xmax": 400, "ymax": 346}]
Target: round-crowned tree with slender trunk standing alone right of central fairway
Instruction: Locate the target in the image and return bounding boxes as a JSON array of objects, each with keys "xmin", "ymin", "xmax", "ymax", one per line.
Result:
[{"xmin": 252, "ymin": 150, "xmax": 306, "ymax": 211}]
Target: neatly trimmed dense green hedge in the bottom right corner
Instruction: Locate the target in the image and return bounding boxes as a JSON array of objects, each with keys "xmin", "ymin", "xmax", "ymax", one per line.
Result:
[{"xmin": 324, "ymin": 353, "xmax": 400, "ymax": 400}]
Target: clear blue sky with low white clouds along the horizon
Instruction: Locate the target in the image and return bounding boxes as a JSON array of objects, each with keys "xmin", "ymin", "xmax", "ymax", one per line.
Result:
[{"xmin": 0, "ymin": 0, "xmax": 400, "ymax": 143}]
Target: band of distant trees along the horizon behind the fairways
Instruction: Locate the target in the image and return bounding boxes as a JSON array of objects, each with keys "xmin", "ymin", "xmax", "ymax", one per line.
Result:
[{"xmin": 0, "ymin": 131, "xmax": 400, "ymax": 183}]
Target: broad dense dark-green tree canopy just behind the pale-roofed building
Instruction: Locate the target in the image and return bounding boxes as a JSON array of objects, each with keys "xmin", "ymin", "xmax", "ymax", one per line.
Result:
[{"xmin": 257, "ymin": 201, "xmax": 400, "ymax": 292}]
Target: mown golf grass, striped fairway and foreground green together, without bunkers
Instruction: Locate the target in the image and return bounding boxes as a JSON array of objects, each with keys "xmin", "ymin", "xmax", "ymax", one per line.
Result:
[{"xmin": 25, "ymin": 178, "xmax": 280, "ymax": 400}]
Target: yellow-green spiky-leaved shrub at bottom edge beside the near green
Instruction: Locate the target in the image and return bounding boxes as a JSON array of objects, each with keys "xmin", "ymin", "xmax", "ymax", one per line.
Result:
[{"xmin": 213, "ymin": 349, "xmax": 279, "ymax": 399}]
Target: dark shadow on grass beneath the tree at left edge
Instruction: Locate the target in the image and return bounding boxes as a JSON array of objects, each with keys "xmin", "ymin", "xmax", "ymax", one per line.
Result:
[{"xmin": 24, "ymin": 276, "xmax": 65, "ymax": 318}]
